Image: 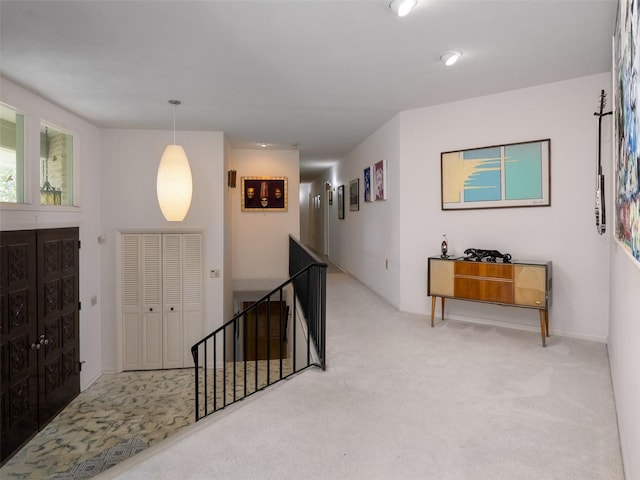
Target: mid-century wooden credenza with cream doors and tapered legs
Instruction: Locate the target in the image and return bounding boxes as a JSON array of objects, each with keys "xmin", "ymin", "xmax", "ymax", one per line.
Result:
[{"xmin": 427, "ymin": 257, "xmax": 552, "ymax": 347}]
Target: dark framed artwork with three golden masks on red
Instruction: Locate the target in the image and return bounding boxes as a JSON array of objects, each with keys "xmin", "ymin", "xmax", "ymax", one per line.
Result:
[{"xmin": 241, "ymin": 177, "xmax": 288, "ymax": 212}]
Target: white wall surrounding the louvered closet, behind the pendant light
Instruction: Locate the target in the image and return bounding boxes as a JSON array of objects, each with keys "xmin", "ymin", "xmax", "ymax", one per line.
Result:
[{"xmin": 102, "ymin": 130, "xmax": 231, "ymax": 371}]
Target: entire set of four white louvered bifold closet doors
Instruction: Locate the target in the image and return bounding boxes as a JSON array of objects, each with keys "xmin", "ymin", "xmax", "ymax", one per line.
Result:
[{"xmin": 121, "ymin": 233, "xmax": 203, "ymax": 370}]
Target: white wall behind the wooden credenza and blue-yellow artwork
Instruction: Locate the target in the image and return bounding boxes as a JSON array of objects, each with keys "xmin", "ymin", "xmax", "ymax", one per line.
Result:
[{"xmin": 400, "ymin": 74, "xmax": 611, "ymax": 342}]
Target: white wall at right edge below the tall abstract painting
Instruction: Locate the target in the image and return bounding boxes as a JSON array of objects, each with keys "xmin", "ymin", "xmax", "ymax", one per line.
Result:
[{"xmin": 609, "ymin": 194, "xmax": 640, "ymax": 479}]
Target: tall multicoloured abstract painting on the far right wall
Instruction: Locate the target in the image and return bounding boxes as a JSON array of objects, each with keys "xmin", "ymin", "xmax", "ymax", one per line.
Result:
[{"xmin": 613, "ymin": 0, "xmax": 640, "ymax": 262}]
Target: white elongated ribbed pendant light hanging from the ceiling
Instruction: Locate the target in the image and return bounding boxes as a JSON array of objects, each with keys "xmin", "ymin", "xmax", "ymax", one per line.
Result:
[{"xmin": 156, "ymin": 100, "xmax": 193, "ymax": 222}]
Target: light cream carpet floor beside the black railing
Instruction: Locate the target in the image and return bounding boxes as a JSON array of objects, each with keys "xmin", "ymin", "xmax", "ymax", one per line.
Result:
[{"xmin": 99, "ymin": 273, "xmax": 623, "ymax": 480}]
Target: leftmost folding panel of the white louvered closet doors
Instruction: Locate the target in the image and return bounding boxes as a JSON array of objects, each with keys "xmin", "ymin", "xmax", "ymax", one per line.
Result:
[{"xmin": 121, "ymin": 235, "xmax": 142, "ymax": 370}]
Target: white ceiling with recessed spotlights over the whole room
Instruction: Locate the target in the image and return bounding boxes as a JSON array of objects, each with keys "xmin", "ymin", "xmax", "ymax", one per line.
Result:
[{"xmin": 0, "ymin": 0, "xmax": 617, "ymax": 181}]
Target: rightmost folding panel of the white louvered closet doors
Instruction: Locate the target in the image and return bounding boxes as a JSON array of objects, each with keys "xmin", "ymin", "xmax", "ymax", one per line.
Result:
[{"xmin": 182, "ymin": 233, "xmax": 204, "ymax": 367}]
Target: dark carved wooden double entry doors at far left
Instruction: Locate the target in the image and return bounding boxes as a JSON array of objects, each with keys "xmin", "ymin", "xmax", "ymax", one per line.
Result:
[{"xmin": 0, "ymin": 228, "xmax": 80, "ymax": 463}]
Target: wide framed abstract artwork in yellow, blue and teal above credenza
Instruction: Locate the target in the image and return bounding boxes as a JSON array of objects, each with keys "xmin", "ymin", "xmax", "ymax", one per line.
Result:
[{"xmin": 440, "ymin": 138, "xmax": 551, "ymax": 210}]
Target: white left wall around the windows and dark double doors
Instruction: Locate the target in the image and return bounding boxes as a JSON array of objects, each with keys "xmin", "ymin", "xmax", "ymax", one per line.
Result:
[{"xmin": 0, "ymin": 78, "xmax": 104, "ymax": 390}]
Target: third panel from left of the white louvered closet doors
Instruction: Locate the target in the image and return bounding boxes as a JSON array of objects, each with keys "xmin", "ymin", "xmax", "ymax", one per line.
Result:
[{"xmin": 162, "ymin": 234, "xmax": 184, "ymax": 368}]
